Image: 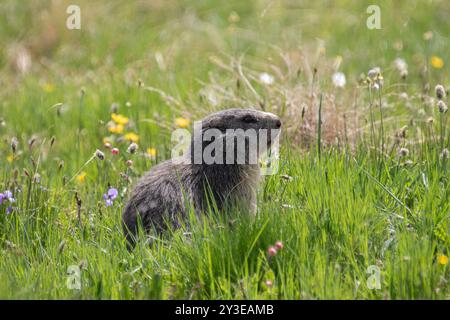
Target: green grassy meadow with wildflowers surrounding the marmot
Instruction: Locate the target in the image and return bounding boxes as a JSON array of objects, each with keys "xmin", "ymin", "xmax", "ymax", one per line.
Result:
[{"xmin": 0, "ymin": 0, "xmax": 450, "ymax": 299}]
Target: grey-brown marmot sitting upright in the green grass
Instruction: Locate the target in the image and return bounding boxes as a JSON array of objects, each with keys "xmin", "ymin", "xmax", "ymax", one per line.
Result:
[{"xmin": 122, "ymin": 109, "xmax": 281, "ymax": 244}]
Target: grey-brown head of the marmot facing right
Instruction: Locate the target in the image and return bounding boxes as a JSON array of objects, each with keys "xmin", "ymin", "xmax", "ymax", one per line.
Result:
[{"xmin": 191, "ymin": 109, "xmax": 281, "ymax": 164}]
